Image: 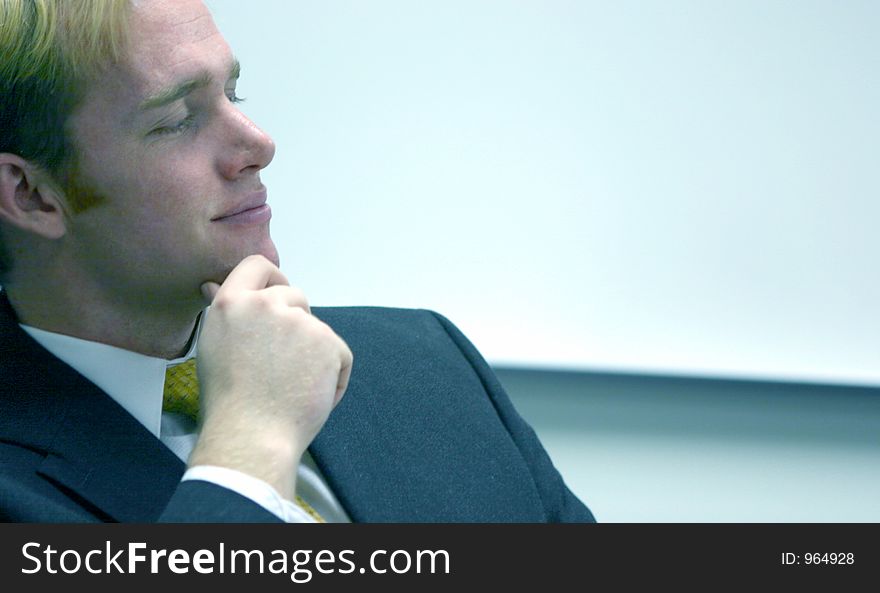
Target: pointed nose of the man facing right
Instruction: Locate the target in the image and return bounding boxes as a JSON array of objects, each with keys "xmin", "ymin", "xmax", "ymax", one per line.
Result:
[{"xmin": 219, "ymin": 105, "xmax": 275, "ymax": 180}]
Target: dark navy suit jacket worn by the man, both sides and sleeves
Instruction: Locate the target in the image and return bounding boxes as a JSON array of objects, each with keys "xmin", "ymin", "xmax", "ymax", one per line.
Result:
[{"xmin": 0, "ymin": 293, "xmax": 593, "ymax": 523}]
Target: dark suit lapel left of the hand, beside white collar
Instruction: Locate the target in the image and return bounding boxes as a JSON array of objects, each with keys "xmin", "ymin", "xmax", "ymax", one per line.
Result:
[{"xmin": 0, "ymin": 292, "xmax": 184, "ymax": 522}]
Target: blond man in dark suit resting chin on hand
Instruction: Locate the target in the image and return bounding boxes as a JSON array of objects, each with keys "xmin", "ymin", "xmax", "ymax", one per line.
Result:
[{"xmin": 0, "ymin": 0, "xmax": 593, "ymax": 522}]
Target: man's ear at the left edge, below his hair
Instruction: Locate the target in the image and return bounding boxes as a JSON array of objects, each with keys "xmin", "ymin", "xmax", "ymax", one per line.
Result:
[{"xmin": 0, "ymin": 152, "xmax": 67, "ymax": 239}]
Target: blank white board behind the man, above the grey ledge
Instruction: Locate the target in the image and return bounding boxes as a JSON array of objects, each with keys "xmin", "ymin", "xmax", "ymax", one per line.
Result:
[{"xmin": 208, "ymin": 0, "xmax": 880, "ymax": 385}]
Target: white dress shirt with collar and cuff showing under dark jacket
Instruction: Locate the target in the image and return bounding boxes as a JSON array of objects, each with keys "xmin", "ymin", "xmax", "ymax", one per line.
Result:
[{"xmin": 21, "ymin": 317, "xmax": 351, "ymax": 523}]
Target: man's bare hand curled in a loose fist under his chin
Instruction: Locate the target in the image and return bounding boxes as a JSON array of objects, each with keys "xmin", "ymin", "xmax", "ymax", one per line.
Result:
[{"xmin": 189, "ymin": 255, "xmax": 352, "ymax": 499}]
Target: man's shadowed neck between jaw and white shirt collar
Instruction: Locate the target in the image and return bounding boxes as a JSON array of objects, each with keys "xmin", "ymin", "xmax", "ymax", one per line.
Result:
[{"xmin": 4, "ymin": 282, "xmax": 204, "ymax": 359}]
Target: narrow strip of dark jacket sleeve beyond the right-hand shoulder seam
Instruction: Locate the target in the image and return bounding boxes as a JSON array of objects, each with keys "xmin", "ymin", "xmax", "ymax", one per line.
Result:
[{"xmin": 429, "ymin": 311, "xmax": 596, "ymax": 523}]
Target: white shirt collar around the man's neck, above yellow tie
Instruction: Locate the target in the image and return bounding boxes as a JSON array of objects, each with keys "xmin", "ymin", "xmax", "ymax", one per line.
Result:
[{"xmin": 20, "ymin": 314, "xmax": 204, "ymax": 438}]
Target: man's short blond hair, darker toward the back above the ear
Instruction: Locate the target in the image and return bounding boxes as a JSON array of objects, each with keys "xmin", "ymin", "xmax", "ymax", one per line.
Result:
[{"xmin": 0, "ymin": 0, "xmax": 130, "ymax": 275}]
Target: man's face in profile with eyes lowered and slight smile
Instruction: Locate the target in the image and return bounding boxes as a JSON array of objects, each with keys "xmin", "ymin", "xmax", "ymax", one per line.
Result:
[{"xmin": 64, "ymin": 0, "xmax": 278, "ymax": 307}]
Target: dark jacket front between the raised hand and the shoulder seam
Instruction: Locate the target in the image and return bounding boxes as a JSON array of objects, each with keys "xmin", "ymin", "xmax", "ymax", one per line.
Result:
[{"xmin": 310, "ymin": 307, "xmax": 544, "ymax": 522}]
